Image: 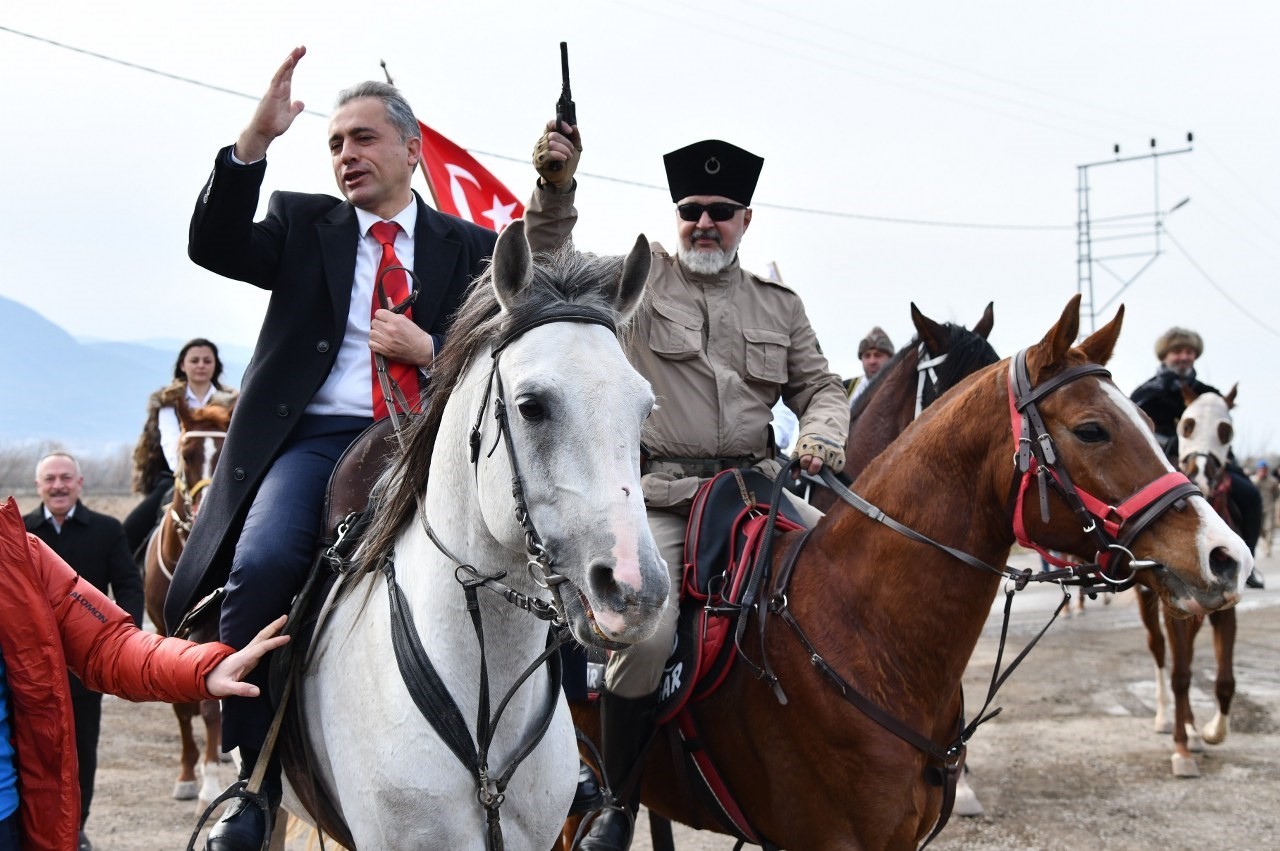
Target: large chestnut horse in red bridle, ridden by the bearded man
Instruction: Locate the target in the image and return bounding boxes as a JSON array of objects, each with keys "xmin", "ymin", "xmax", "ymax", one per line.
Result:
[{"xmin": 560, "ymin": 297, "xmax": 1253, "ymax": 851}]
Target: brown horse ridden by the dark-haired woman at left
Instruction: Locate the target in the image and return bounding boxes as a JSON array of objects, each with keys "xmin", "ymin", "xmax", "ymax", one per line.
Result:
[{"xmin": 143, "ymin": 404, "xmax": 232, "ymax": 809}]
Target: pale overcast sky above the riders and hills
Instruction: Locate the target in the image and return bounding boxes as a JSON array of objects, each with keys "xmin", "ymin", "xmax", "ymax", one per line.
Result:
[{"xmin": 0, "ymin": 0, "xmax": 1280, "ymax": 454}]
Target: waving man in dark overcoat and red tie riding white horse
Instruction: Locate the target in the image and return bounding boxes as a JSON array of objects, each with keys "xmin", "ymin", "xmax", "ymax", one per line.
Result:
[{"xmin": 165, "ymin": 47, "xmax": 495, "ymax": 851}]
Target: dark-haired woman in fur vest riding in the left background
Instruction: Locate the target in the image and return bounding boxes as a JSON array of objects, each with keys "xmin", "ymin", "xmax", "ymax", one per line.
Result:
[{"xmin": 124, "ymin": 337, "xmax": 239, "ymax": 555}]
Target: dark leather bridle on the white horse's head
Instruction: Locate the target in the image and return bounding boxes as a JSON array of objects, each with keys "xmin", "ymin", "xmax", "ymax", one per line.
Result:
[{"xmin": 463, "ymin": 305, "xmax": 625, "ymax": 650}]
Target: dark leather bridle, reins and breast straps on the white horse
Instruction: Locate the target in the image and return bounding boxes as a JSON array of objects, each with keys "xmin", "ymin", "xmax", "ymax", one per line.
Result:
[{"xmin": 363, "ymin": 289, "xmax": 621, "ymax": 851}]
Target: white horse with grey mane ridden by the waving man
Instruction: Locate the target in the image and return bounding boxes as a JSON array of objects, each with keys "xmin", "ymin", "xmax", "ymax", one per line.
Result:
[{"xmin": 291, "ymin": 221, "xmax": 668, "ymax": 851}]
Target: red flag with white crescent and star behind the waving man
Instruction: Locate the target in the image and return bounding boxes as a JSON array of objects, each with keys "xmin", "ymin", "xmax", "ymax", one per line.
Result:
[{"xmin": 417, "ymin": 122, "xmax": 525, "ymax": 232}]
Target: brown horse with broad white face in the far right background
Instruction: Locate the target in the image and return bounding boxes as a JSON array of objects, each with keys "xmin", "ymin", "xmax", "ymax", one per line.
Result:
[{"xmin": 1138, "ymin": 386, "xmax": 1239, "ymax": 777}]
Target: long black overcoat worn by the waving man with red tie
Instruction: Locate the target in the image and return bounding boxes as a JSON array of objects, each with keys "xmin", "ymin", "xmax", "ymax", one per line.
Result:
[{"xmin": 165, "ymin": 147, "xmax": 497, "ymax": 628}]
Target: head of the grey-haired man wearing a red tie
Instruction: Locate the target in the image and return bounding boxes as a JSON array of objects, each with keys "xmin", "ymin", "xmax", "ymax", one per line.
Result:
[{"xmin": 329, "ymin": 97, "xmax": 422, "ymax": 219}]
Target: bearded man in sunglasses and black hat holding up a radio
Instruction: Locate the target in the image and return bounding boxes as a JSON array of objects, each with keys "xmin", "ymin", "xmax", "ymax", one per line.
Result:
[{"xmin": 525, "ymin": 122, "xmax": 849, "ymax": 851}]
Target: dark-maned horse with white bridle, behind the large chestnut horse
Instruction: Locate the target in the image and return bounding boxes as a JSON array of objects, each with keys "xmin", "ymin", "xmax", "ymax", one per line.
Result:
[{"xmin": 809, "ymin": 302, "xmax": 1000, "ymax": 512}]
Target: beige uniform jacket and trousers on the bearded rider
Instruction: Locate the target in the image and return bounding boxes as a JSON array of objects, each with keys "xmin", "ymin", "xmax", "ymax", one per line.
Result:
[{"xmin": 525, "ymin": 188, "xmax": 849, "ymax": 697}]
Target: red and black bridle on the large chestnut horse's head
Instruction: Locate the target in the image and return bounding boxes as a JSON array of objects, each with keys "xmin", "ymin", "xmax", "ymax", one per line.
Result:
[{"xmin": 1009, "ymin": 349, "xmax": 1201, "ymax": 587}]
